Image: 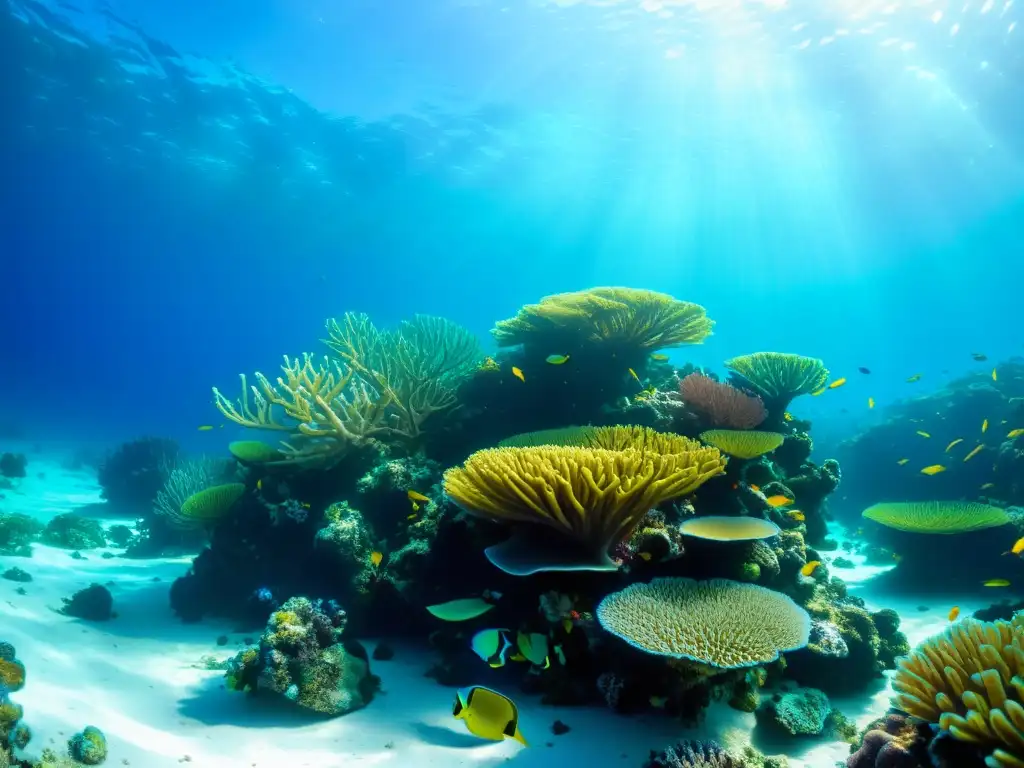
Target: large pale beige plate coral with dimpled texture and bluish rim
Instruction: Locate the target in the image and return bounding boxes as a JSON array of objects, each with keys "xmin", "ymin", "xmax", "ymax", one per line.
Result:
[{"xmin": 597, "ymin": 579, "xmax": 811, "ymax": 669}]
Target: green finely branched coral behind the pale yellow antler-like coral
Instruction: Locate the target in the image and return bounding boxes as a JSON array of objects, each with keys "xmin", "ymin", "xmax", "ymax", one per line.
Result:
[{"xmin": 324, "ymin": 312, "xmax": 483, "ymax": 440}]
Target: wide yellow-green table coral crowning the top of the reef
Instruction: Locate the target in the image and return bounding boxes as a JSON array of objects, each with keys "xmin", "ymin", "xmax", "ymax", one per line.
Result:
[{"xmin": 492, "ymin": 288, "xmax": 713, "ymax": 350}]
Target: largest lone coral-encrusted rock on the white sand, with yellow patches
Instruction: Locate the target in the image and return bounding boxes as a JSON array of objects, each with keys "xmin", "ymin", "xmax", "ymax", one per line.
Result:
[{"xmin": 225, "ymin": 597, "xmax": 379, "ymax": 716}]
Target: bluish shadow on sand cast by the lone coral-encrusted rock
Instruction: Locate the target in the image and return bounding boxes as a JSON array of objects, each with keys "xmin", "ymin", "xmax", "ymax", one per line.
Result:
[{"xmin": 178, "ymin": 676, "xmax": 335, "ymax": 728}]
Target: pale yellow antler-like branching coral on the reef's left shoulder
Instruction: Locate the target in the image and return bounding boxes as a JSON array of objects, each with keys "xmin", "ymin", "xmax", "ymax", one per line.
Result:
[{"xmin": 213, "ymin": 354, "xmax": 393, "ymax": 466}]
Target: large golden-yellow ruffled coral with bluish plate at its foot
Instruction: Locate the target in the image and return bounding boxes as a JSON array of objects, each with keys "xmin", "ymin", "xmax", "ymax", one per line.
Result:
[{"xmin": 444, "ymin": 443, "xmax": 724, "ymax": 574}]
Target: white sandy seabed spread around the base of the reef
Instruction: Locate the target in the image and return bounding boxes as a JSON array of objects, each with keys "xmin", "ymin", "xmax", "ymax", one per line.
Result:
[{"xmin": 0, "ymin": 450, "xmax": 980, "ymax": 768}]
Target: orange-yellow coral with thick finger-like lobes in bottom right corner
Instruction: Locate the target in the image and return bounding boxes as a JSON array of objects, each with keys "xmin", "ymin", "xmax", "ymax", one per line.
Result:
[{"xmin": 893, "ymin": 618, "xmax": 1024, "ymax": 768}]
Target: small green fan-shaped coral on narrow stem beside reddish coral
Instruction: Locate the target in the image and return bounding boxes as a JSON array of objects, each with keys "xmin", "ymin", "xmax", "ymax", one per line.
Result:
[{"xmin": 725, "ymin": 352, "xmax": 828, "ymax": 418}]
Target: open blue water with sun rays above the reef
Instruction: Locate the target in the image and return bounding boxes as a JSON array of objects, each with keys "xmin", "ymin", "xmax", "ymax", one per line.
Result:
[{"xmin": 0, "ymin": 0, "xmax": 1024, "ymax": 450}]
